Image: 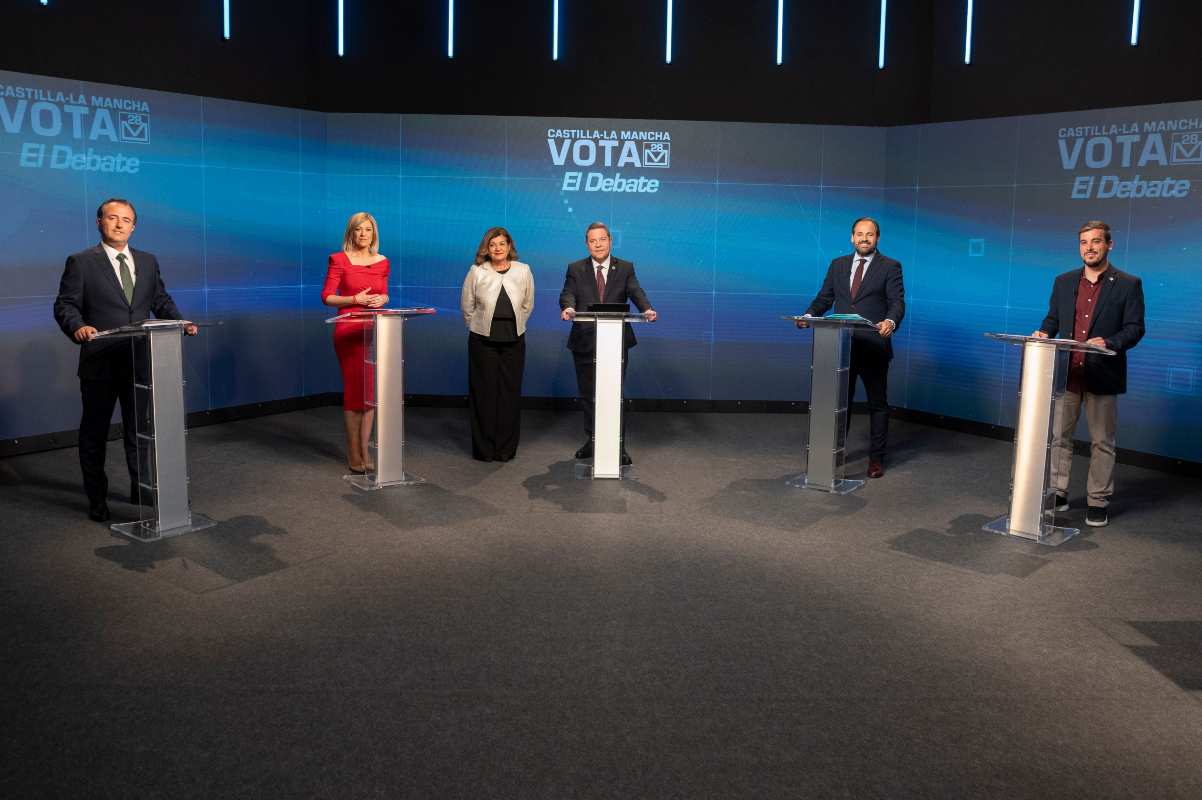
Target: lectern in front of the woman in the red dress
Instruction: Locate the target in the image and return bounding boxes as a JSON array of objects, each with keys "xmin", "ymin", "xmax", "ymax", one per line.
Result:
[{"xmin": 326, "ymin": 308, "xmax": 435, "ymax": 491}]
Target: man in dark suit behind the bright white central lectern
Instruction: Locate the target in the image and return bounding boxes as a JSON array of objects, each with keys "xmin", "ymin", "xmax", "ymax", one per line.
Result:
[{"xmin": 559, "ymin": 222, "xmax": 656, "ymax": 465}]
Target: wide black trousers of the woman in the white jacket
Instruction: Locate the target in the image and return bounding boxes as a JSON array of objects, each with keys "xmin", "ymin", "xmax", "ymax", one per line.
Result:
[{"xmin": 468, "ymin": 334, "xmax": 525, "ymax": 461}]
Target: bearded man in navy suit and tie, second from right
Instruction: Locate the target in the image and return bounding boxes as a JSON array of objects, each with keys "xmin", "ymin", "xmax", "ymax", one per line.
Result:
[{"xmin": 797, "ymin": 216, "xmax": 905, "ymax": 478}]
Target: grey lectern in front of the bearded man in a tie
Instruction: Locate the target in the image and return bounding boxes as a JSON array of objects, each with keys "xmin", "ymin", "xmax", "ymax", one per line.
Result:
[{"xmin": 781, "ymin": 314, "xmax": 874, "ymax": 495}]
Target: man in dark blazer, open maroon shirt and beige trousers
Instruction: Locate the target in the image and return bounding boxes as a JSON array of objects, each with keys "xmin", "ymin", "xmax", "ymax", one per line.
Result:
[{"xmin": 1031, "ymin": 220, "xmax": 1143, "ymax": 526}]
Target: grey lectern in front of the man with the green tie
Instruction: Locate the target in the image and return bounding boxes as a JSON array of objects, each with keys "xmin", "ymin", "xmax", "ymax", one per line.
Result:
[{"xmin": 93, "ymin": 320, "xmax": 216, "ymax": 542}]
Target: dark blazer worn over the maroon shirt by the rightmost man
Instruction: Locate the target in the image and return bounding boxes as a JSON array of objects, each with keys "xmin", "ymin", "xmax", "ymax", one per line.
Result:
[{"xmin": 1040, "ymin": 264, "xmax": 1143, "ymax": 394}]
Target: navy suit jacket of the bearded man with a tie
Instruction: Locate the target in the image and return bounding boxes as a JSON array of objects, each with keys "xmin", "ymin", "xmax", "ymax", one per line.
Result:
[{"xmin": 805, "ymin": 251, "xmax": 905, "ymax": 358}]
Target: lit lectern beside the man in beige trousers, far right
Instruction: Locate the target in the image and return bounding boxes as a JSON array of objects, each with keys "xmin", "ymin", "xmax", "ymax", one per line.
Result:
[{"xmin": 984, "ymin": 333, "xmax": 1114, "ymax": 545}]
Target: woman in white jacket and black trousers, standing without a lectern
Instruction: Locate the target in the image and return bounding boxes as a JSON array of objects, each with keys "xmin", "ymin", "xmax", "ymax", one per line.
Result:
[{"xmin": 459, "ymin": 228, "xmax": 534, "ymax": 461}]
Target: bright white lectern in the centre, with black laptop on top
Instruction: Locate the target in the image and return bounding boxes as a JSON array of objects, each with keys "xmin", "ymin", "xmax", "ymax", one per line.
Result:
[{"xmin": 576, "ymin": 311, "xmax": 647, "ymax": 479}]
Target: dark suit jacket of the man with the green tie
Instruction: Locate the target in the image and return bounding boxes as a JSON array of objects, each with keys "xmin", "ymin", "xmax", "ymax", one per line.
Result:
[{"xmin": 54, "ymin": 245, "xmax": 183, "ymax": 380}]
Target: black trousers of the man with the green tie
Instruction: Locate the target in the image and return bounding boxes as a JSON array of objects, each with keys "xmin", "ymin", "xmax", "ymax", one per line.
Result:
[{"xmin": 79, "ymin": 376, "xmax": 138, "ymax": 503}]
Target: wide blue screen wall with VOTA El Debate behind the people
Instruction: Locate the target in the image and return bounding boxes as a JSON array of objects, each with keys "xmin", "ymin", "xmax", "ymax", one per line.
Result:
[{"xmin": 0, "ymin": 72, "xmax": 1202, "ymax": 460}]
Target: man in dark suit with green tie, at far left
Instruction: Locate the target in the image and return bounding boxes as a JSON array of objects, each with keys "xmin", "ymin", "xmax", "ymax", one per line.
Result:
[{"xmin": 54, "ymin": 198, "xmax": 196, "ymax": 523}]
